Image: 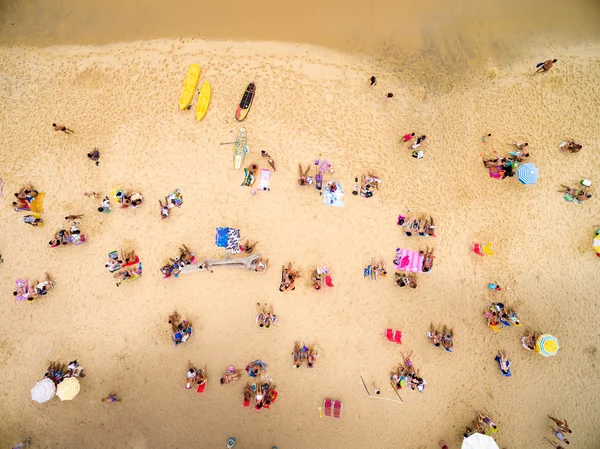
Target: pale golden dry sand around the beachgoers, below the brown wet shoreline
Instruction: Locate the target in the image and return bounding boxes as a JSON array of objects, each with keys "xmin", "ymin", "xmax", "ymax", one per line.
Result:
[{"xmin": 0, "ymin": 3, "xmax": 600, "ymax": 449}]
